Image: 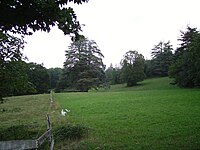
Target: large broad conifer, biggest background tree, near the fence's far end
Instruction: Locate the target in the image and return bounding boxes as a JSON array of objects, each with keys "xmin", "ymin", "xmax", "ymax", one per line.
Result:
[{"xmin": 57, "ymin": 38, "xmax": 105, "ymax": 92}]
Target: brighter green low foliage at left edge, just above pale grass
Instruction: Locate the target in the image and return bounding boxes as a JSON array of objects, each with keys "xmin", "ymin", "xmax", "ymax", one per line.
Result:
[{"xmin": 0, "ymin": 61, "xmax": 31, "ymax": 97}]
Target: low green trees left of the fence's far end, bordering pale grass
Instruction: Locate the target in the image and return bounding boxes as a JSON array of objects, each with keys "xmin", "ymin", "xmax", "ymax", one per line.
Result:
[{"xmin": 0, "ymin": 61, "xmax": 49, "ymax": 97}]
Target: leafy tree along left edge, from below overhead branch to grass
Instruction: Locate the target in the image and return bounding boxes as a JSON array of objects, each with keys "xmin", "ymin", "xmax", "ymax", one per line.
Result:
[{"xmin": 0, "ymin": 32, "xmax": 26, "ymax": 100}]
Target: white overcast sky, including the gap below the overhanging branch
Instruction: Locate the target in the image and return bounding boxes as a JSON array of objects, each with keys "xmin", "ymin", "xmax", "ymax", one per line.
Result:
[{"xmin": 24, "ymin": 0, "xmax": 200, "ymax": 68}]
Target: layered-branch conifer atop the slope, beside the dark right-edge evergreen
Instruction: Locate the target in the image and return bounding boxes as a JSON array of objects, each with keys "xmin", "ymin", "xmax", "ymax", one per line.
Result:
[{"xmin": 151, "ymin": 41, "xmax": 173, "ymax": 76}]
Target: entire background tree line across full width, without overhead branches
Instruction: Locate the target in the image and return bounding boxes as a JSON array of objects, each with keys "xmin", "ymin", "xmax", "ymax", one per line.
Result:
[{"xmin": 0, "ymin": 27, "xmax": 200, "ymax": 100}]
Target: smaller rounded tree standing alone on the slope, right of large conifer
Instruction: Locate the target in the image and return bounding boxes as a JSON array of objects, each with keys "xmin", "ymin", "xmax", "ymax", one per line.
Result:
[{"xmin": 121, "ymin": 51, "xmax": 145, "ymax": 86}]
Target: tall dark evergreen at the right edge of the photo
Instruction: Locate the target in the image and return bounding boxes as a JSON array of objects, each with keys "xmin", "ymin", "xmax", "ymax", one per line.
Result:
[{"xmin": 170, "ymin": 27, "xmax": 200, "ymax": 87}]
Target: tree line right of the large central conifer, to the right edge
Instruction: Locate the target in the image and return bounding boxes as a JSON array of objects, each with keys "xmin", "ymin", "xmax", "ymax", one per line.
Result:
[{"xmin": 105, "ymin": 26, "xmax": 200, "ymax": 87}]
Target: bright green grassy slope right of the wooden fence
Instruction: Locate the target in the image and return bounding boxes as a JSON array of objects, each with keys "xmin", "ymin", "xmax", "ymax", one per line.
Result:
[{"xmin": 55, "ymin": 78, "xmax": 200, "ymax": 149}]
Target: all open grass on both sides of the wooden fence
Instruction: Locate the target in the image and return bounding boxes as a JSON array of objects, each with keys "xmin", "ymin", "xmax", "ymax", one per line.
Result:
[{"xmin": 0, "ymin": 78, "xmax": 200, "ymax": 150}]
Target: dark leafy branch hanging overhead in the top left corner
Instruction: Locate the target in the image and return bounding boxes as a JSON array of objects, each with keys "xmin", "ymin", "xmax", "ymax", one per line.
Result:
[{"xmin": 0, "ymin": 0, "xmax": 88, "ymax": 37}]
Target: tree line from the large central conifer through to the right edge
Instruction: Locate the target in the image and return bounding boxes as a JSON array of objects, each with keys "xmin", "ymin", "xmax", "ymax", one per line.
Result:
[{"xmin": 56, "ymin": 26, "xmax": 200, "ymax": 92}]
